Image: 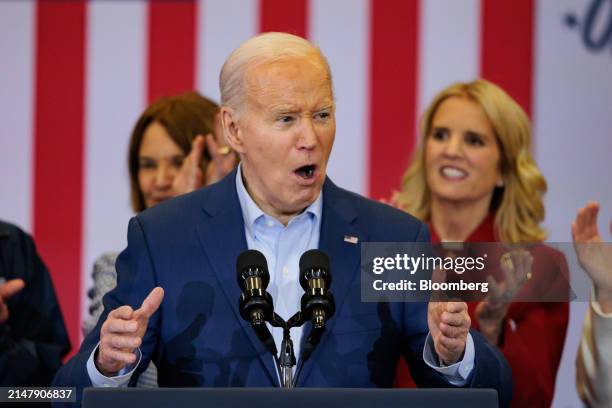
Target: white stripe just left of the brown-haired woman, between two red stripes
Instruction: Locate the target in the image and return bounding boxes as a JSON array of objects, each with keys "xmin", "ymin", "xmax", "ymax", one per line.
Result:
[{"xmin": 81, "ymin": 1, "xmax": 147, "ymax": 334}]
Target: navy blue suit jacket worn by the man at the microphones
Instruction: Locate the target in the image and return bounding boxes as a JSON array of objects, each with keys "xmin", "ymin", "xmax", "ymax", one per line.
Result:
[{"xmin": 55, "ymin": 172, "xmax": 511, "ymax": 406}]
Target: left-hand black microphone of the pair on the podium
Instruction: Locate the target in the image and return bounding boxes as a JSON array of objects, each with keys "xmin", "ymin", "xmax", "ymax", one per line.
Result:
[{"xmin": 236, "ymin": 249, "xmax": 274, "ymax": 327}]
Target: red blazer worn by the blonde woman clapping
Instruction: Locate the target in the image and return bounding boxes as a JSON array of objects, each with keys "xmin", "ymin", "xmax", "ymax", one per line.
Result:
[{"xmin": 395, "ymin": 215, "xmax": 569, "ymax": 408}]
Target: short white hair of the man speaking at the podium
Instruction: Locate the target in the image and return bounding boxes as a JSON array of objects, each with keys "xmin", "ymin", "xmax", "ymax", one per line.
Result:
[{"xmin": 219, "ymin": 32, "xmax": 333, "ymax": 115}]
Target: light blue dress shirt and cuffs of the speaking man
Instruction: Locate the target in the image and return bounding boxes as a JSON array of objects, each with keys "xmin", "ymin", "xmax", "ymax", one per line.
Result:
[{"xmin": 87, "ymin": 165, "xmax": 475, "ymax": 387}]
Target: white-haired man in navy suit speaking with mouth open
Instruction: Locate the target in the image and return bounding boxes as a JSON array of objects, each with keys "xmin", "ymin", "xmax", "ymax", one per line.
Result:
[{"xmin": 56, "ymin": 33, "xmax": 511, "ymax": 405}]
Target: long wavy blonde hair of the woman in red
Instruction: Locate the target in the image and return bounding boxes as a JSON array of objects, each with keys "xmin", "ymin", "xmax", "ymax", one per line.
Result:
[{"xmin": 398, "ymin": 79, "xmax": 547, "ymax": 243}]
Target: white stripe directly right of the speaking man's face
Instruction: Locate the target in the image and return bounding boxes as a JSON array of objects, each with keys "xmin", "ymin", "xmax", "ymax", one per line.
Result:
[{"xmin": 308, "ymin": 0, "xmax": 370, "ymax": 194}]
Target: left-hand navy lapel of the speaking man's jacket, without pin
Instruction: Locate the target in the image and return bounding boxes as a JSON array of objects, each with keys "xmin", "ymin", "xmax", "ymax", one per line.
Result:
[{"xmin": 196, "ymin": 170, "xmax": 278, "ymax": 385}]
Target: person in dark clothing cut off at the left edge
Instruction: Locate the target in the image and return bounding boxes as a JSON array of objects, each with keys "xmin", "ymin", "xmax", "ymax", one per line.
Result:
[{"xmin": 0, "ymin": 221, "xmax": 70, "ymax": 387}]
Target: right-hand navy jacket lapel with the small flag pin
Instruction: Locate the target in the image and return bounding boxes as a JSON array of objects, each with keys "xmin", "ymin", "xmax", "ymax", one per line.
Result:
[{"xmin": 298, "ymin": 179, "xmax": 368, "ymax": 386}]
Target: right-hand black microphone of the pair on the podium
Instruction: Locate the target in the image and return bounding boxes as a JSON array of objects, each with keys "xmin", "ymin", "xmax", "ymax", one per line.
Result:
[{"xmin": 300, "ymin": 249, "xmax": 336, "ymax": 329}]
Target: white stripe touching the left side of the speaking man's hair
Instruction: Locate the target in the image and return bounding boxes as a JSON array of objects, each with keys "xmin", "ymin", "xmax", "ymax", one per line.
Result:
[{"xmin": 196, "ymin": 0, "xmax": 259, "ymax": 102}]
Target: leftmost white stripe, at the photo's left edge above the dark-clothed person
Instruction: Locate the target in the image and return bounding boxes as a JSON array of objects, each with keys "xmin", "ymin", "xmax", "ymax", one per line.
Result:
[{"xmin": 0, "ymin": 0, "xmax": 35, "ymax": 231}]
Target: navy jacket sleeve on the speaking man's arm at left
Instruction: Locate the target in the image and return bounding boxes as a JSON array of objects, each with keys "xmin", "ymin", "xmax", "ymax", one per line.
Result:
[{"xmin": 54, "ymin": 216, "xmax": 163, "ymax": 406}]
